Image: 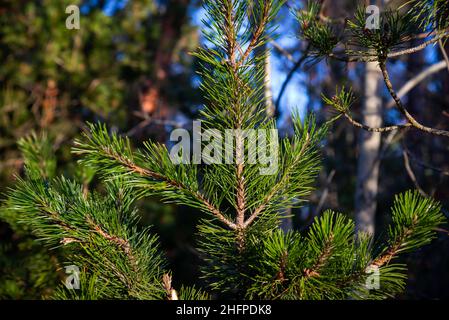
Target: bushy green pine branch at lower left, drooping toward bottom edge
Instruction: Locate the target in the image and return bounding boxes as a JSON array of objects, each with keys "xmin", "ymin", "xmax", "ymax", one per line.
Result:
[{"xmin": 8, "ymin": 178, "xmax": 168, "ymax": 299}]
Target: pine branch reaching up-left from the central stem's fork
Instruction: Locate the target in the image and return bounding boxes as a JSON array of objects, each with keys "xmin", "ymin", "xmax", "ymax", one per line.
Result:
[{"xmin": 73, "ymin": 125, "xmax": 236, "ymax": 229}]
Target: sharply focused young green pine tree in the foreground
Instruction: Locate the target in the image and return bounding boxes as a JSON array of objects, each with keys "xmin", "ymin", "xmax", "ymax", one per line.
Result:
[{"xmin": 1, "ymin": 0, "xmax": 444, "ymax": 299}]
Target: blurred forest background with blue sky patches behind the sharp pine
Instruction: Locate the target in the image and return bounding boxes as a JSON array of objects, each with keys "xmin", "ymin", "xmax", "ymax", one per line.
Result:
[{"xmin": 0, "ymin": 0, "xmax": 449, "ymax": 299}]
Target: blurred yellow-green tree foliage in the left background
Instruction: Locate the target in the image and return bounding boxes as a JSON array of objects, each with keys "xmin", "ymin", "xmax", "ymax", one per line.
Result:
[{"xmin": 0, "ymin": 0, "xmax": 197, "ymax": 299}]
